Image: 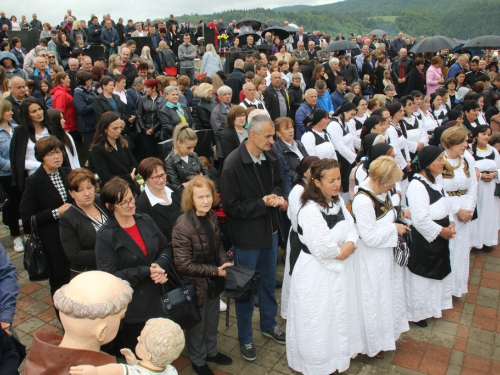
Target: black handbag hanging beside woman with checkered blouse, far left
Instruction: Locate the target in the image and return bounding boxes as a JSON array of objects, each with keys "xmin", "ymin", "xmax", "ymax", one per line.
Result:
[{"xmin": 23, "ymin": 215, "xmax": 50, "ymax": 281}]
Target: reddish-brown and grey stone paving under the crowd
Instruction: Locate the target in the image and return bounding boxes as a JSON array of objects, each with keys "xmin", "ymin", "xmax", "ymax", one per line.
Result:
[{"xmin": 0, "ymin": 223, "xmax": 500, "ymax": 375}]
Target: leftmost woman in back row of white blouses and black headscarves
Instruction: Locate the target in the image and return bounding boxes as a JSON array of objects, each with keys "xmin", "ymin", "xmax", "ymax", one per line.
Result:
[{"xmin": 301, "ymin": 109, "xmax": 337, "ymax": 159}]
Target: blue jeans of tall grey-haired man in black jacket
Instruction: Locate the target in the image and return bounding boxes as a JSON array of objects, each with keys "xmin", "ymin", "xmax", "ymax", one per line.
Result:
[{"xmin": 233, "ymin": 232, "xmax": 278, "ymax": 344}]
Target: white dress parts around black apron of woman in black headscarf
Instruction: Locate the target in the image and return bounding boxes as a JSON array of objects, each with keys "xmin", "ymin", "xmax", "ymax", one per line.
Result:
[{"xmin": 403, "ymin": 173, "xmax": 453, "ymax": 322}]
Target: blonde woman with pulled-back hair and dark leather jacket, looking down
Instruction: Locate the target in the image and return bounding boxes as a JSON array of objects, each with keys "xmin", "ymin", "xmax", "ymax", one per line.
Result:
[{"xmin": 165, "ymin": 124, "xmax": 210, "ymax": 191}]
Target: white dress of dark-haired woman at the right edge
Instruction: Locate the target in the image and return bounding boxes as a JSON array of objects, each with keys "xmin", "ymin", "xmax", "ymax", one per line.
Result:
[{"xmin": 471, "ymin": 145, "xmax": 500, "ymax": 249}]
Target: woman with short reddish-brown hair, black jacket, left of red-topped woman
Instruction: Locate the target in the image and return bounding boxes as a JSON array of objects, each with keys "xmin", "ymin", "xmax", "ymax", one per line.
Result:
[{"xmin": 59, "ymin": 168, "xmax": 108, "ymax": 278}]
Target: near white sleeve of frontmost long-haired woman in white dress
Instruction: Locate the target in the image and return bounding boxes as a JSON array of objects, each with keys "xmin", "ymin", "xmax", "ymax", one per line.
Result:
[{"xmin": 298, "ymin": 202, "xmax": 344, "ymax": 272}]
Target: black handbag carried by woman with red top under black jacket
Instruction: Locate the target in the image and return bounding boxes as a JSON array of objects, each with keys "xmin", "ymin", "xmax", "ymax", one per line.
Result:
[{"xmin": 160, "ymin": 255, "xmax": 201, "ymax": 329}]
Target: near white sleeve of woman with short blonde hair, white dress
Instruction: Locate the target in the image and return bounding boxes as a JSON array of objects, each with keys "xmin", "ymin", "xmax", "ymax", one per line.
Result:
[{"xmin": 352, "ymin": 194, "xmax": 398, "ymax": 247}]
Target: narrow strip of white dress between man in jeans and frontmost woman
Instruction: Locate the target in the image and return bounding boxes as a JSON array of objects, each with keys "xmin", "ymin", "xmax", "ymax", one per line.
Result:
[{"xmin": 281, "ymin": 184, "xmax": 304, "ymax": 319}]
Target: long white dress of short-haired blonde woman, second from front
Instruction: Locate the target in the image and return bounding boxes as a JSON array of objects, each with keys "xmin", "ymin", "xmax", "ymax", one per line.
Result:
[{"xmin": 352, "ymin": 178, "xmax": 409, "ymax": 357}]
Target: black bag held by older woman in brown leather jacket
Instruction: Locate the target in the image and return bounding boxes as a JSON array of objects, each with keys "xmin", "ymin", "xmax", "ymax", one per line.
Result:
[{"xmin": 224, "ymin": 265, "xmax": 260, "ymax": 301}]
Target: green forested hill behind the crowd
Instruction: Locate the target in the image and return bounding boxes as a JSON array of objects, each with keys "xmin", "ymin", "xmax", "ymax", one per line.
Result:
[{"xmin": 176, "ymin": 0, "xmax": 500, "ymax": 39}]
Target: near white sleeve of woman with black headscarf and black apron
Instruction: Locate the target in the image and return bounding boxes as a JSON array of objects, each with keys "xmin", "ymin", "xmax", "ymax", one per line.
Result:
[{"xmin": 406, "ymin": 179, "xmax": 442, "ymax": 242}]
